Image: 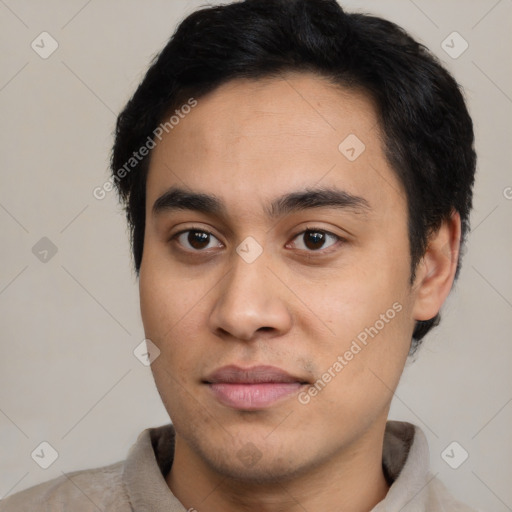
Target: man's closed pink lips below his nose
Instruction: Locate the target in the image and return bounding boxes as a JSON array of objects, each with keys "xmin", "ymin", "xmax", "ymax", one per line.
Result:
[{"xmin": 203, "ymin": 365, "xmax": 309, "ymax": 411}]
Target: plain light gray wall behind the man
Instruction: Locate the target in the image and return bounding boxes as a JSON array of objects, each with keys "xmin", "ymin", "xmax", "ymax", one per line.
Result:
[{"xmin": 0, "ymin": 0, "xmax": 512, "ymax": 512}]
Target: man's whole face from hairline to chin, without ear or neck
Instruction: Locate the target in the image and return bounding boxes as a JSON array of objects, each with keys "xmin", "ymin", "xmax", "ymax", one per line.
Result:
[{"xmin": 140, "ymin": 74, "xmax": 416, "ymax": 481}]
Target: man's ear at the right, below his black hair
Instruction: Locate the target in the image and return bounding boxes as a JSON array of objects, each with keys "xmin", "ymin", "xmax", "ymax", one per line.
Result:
[{"xmin": 413, "ymin": 208, "xmax": 461, "ymax": 320}]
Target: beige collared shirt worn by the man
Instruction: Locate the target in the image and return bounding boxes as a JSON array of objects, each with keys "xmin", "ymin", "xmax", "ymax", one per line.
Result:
[{"xmin": 0, "ymin": 421, "xmax": 475, "ymax": 512}]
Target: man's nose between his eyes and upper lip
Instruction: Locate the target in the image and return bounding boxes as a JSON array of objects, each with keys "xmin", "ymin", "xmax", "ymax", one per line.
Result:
[{"xmin": 209, "ymin": 246, "xmax": 292, "ymax": 341}]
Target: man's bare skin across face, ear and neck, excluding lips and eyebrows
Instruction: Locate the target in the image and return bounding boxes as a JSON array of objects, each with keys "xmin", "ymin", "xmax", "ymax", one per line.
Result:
[{"xmin": 140, "ymin": 73, "xmax": 460, "ymax": 512}]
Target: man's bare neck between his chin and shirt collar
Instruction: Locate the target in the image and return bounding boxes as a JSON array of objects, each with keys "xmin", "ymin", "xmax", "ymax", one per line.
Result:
[{"xmin": 167, "ymin": 423, "xmax": 389, "ymax": 512}]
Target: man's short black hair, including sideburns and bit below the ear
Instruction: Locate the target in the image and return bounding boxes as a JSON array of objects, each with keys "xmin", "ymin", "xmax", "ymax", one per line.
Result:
[{"xmin": 111, "ymin": 0, "xmax": 476, "ymax": 353}]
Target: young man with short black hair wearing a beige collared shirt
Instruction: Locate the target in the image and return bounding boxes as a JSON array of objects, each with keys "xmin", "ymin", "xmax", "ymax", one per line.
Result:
[{"xmin": 0, "ymin": 0, "xmax": 476, "ymax": 512}]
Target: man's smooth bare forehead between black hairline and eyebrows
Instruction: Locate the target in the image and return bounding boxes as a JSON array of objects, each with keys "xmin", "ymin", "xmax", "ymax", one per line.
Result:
[{"xmin": 147, "ymin": 74, "xmax": 402, "ymax": 220}]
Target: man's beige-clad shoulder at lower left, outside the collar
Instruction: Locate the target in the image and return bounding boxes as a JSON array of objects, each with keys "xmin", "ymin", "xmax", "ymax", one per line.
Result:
[{"xmin": 0, "ymin": 461, "xmax": 131, "ymax": 512}]
